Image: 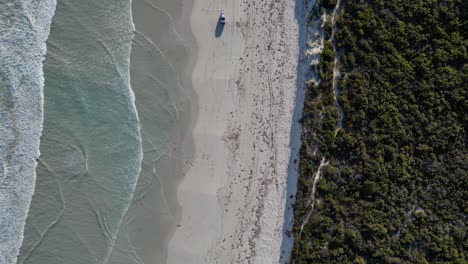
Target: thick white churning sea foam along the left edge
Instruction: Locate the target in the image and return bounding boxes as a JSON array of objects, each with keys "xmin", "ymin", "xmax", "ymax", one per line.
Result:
[{"xmin": 0, "ymin": 0, "xmax": 56, "ymax": 264}]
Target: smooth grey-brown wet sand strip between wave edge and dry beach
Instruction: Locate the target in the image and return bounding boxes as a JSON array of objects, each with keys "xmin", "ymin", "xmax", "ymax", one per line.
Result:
[{"xmin": 110, "ymin": 0, "xmax": 197, "ymax": 264}]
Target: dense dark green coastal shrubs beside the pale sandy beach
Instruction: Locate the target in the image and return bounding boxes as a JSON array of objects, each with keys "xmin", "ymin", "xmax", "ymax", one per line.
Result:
[{"xmin": 293, "ymin": 0, "xmax": 468, "ymax": 264}]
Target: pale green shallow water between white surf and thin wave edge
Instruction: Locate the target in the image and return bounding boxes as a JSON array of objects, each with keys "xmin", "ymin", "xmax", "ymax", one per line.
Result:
[{"xmin": 17, "ymin": 0, "xmax": 142, "ymax": 264}]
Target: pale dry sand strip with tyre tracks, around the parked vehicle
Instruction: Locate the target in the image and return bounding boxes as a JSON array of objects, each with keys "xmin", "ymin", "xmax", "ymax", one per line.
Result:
[{"xmin": 168, "ymin": 0, "xmax": 298, "ymax": 264}]
